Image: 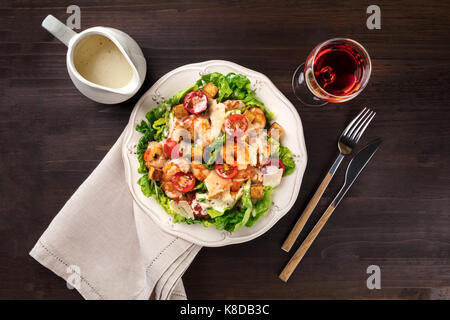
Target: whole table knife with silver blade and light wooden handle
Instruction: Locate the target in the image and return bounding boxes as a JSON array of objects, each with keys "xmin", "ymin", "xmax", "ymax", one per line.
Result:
[{"xmin": 279, "ymin": 139, "xmax": 382, "ymax": 282}]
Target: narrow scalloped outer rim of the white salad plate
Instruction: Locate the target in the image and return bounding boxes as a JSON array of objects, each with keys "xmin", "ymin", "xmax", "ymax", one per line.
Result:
[{"xmin": 122, "ymin": 60, "xmax": 308, "ymax": 247}]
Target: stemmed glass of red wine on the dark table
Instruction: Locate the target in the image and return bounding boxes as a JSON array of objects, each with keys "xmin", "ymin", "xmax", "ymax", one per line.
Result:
[{"xmin": 292, "ymin": 38, "xmax": 372, "ymax": 107}]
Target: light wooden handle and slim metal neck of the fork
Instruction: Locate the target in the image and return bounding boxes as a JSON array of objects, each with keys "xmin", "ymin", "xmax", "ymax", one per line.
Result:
[{"xmin": 281, "ymin": 154, "xmax": 344, "ymax": 252}]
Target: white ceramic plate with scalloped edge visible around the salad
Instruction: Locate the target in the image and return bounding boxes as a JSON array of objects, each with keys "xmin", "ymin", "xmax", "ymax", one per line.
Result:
[{"xmin": 122, "ymin": 60, "xmax": 307, "ymax": 247}]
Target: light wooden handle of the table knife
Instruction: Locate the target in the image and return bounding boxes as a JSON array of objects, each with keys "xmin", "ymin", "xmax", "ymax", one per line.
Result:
[{"xmin": 279, "ymin": 204, "xmax": 335, "ymax": 282}]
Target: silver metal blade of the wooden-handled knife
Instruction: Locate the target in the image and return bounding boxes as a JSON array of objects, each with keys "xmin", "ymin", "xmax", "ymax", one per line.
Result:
[{"xmin": 331, "ymin": 139, "xmax": 383, "ymax": 208}]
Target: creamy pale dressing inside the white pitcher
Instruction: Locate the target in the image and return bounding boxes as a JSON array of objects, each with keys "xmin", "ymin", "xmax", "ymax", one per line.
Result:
[{"xmin": 73, "ymin": 34, "xmax": 133, "ymax": 89}]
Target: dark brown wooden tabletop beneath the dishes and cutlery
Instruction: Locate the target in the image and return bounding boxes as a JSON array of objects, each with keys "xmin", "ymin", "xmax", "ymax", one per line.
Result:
[{"xmin": 0, "ymin": 0, "xmax": 450, "ymax": 299}]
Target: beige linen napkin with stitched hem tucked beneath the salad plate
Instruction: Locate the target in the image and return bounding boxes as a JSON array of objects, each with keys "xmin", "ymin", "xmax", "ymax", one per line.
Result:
[{"xmin": 30, "ymin": 129, "xmax": 201, "ymax": 299}]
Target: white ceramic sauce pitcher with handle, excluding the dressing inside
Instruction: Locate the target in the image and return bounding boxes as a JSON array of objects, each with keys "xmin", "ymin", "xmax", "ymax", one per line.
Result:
[{"xmin": 42, "ymin": 15, "xmax": 147, "ymax": 104}]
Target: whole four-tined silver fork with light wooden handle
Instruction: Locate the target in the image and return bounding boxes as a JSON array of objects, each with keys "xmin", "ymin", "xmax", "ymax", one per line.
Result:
[{"xmin": 281, "ymin": 108, "xmax": 376, "ymax": 252}]
